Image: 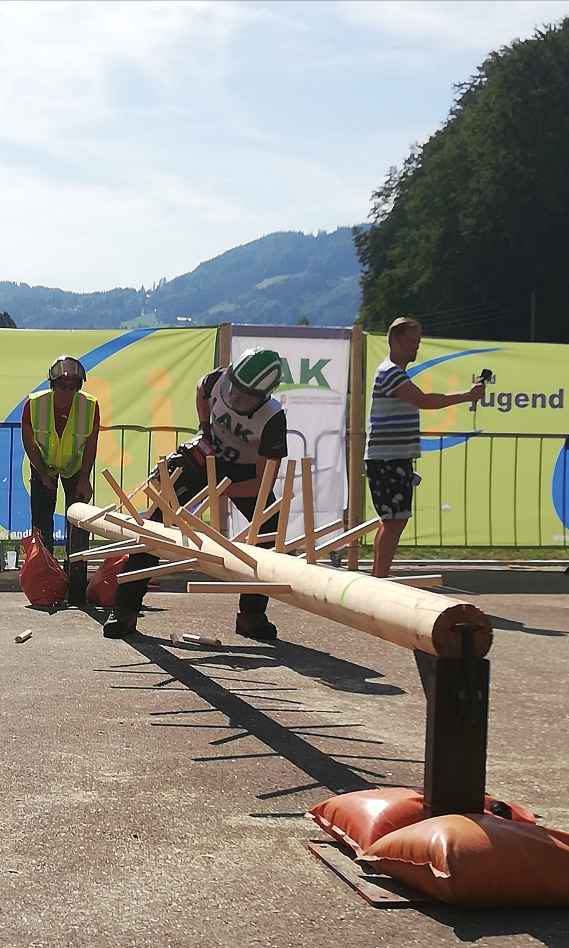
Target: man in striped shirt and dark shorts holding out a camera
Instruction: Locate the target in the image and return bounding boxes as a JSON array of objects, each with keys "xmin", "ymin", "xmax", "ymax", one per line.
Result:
[{"xmin": 365, "ymin": 316, "xmax": 484, "ymax": 576}]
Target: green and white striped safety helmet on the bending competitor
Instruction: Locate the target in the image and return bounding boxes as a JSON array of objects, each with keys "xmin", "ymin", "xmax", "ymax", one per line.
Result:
[{"xmin": 221, "ymin": 346, "xmax": 282, "ymax": 415}]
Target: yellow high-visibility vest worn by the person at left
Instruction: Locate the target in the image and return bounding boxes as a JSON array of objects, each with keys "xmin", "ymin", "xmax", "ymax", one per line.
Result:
[{"xmin": 30, "ymin": 389, "xmax": 97, "ymax": 477}]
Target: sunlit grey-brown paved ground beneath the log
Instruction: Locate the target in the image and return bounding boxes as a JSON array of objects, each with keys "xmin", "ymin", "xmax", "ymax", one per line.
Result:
[{"xmin": 0, "ymin": 573, "xmax": 569, "ymax": 948}]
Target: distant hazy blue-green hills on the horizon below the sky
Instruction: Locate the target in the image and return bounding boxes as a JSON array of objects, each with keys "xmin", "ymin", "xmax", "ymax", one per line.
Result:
[{"xmin": 0, "ymin": 227, "xmax": 361, "ymax": 329}]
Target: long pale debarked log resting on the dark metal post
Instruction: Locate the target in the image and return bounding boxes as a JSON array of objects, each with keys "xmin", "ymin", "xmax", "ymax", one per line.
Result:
[{"xmin": 67, "ymin": 503, "xmax": 492, "ymax": 658}]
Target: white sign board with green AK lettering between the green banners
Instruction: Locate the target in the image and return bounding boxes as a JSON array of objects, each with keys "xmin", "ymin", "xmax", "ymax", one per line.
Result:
[{"xmin": 231, "ymin": 326, "xmax": 350, "ymax": 539}]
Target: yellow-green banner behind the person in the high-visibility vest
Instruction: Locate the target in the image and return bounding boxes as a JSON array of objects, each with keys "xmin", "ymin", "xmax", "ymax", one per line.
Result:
[{"xmin": 0, "ymin": 329, "xmax": 217, "ymax": 539}]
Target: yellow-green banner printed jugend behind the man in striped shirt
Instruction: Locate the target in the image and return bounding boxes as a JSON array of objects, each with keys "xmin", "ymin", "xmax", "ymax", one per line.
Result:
[{"xmin": 366, "ymin": 335, "xmax": 569, "ymax": 546}]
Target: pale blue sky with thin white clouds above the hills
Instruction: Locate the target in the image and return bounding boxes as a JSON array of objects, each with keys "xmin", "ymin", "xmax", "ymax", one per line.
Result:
[{"xmin": 0, "ymin": 0, "xmax": 569, "ymax": 291}]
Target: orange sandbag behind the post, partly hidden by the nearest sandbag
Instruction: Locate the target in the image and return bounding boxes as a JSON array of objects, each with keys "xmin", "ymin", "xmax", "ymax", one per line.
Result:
[{"xmin": 306, "ymin": 787, "xmax": 535, "ymax": 855}]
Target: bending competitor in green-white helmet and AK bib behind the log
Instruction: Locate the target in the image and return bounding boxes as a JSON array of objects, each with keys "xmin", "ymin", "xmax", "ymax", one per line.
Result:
[{"xmin": 103, "ymin": 347, "xmax": 287, "ymax": 642}]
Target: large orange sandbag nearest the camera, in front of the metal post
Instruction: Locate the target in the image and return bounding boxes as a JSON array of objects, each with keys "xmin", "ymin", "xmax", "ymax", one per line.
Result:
[{"xmin": 359, "ymin": 814, "xmax": 569, "ymax": 908}]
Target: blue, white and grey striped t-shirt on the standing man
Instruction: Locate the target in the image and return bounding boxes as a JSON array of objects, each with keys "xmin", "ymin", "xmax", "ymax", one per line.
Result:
[{"xmin": 365, "ymin": 358, "xmax": 421, "ymax": 461}]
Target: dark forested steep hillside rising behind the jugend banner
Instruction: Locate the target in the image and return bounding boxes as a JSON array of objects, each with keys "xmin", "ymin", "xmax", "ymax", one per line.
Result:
[{"xmin": 357, "ymin": 19, "xmax": 569, "ymax": 342}]
